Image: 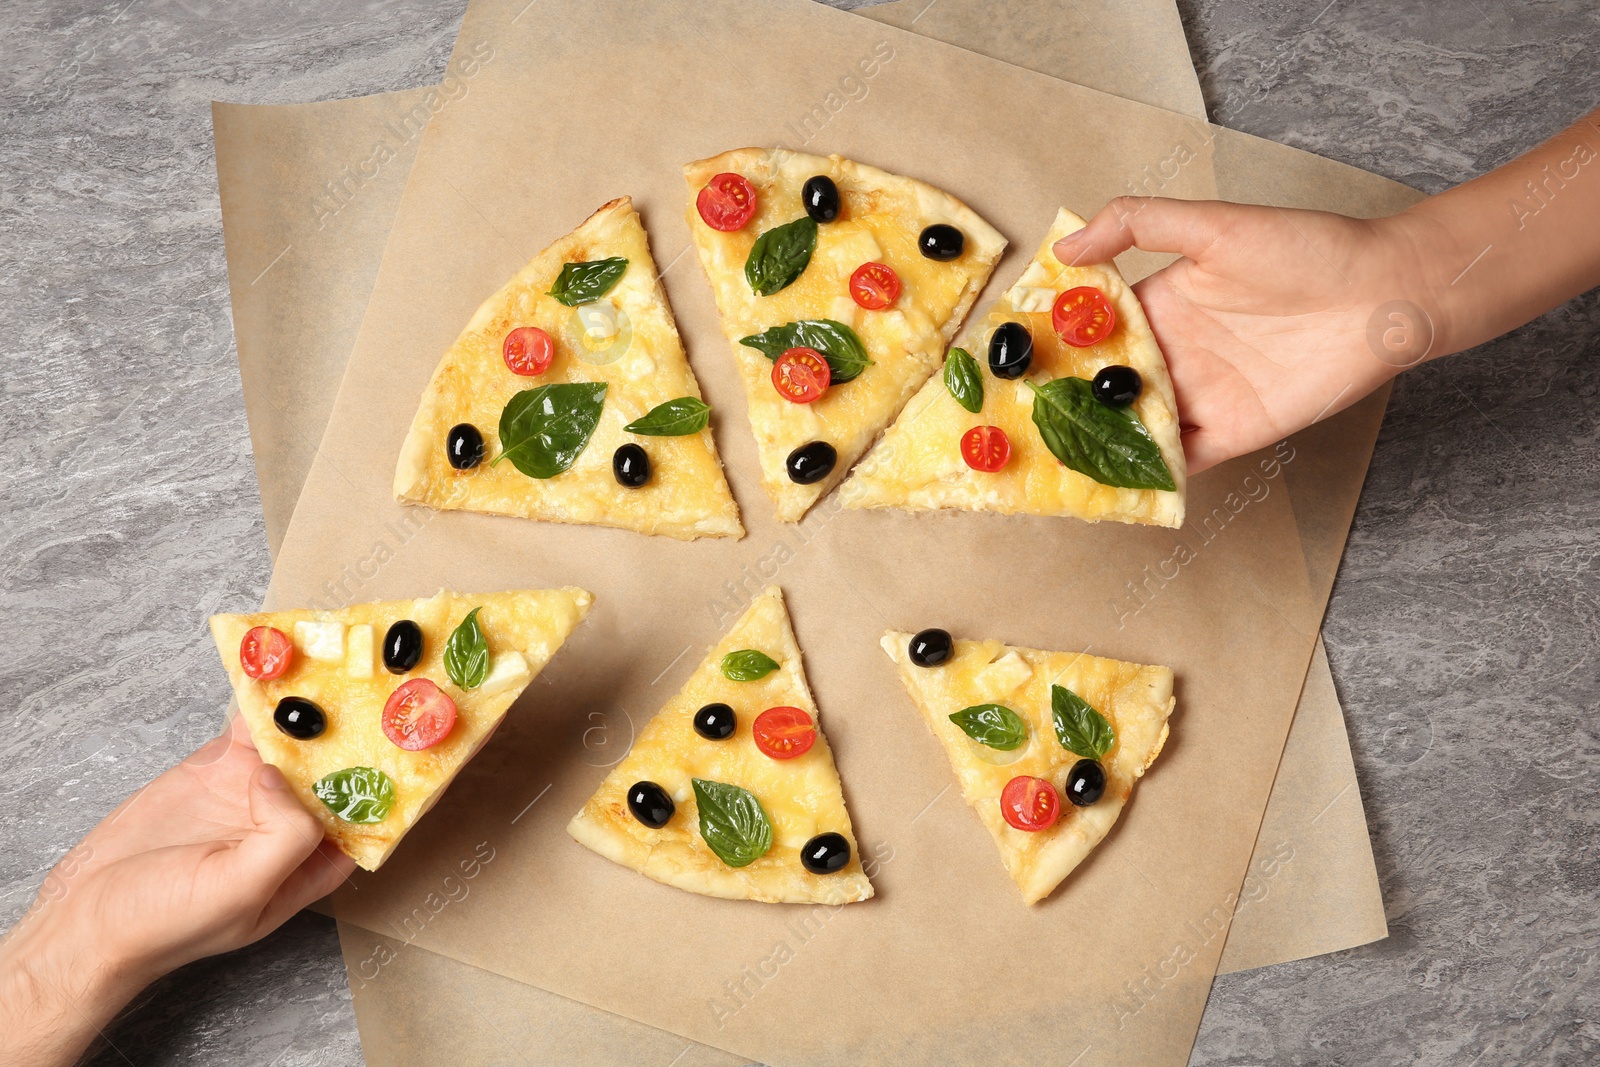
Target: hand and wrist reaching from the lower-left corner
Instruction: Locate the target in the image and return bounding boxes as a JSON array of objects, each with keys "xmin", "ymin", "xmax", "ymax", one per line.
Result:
[{"xmin": 0, "ymin": 717, "xmax": 355, "ymax": 1064}]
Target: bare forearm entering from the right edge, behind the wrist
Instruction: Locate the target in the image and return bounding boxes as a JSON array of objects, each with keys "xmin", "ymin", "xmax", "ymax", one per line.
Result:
[{"xmin": 1392, "ymin": 110, "xmax": 1600, "ymax": 357}]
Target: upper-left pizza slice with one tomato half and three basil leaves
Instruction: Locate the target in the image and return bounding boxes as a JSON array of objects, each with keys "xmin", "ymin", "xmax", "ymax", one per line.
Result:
[{"xmin": 394, "ymin": 197, "xmax": 744, "ymax": 541}]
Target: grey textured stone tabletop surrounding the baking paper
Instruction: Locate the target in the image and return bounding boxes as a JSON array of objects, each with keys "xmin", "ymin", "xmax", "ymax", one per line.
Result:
[{"xmin": 0, "ymin": 0, "xmax": 1600, "ymax": 1067}]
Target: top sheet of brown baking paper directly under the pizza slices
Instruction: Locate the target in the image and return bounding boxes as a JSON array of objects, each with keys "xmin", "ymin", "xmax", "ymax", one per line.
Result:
[{"xmin": 243, "ymin": 3, "xmax": 1337, "ymax": 1064}]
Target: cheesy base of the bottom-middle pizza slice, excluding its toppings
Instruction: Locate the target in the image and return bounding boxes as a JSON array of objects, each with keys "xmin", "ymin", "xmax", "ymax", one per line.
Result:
[{"xmin": 568, "ymin": 589, "xmax": 872, "ymax": 904}]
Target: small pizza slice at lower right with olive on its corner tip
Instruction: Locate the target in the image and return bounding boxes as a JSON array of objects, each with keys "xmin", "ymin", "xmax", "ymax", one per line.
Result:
[{"xmin": 882, "ymin": 630, "xmax": 1174, "ymax": 904}]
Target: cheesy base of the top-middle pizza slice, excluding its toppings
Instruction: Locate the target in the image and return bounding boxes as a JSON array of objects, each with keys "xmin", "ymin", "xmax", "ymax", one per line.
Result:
[{"xmin": 685, "ymin": 149, "xmax": 1005, "ymax": 522}]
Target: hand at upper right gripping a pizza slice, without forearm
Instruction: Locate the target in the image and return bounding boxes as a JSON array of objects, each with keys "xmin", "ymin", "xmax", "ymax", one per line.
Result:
[{"xmin": 1054, "ymin": 197, "xmax": 1446, "ymax": 474}]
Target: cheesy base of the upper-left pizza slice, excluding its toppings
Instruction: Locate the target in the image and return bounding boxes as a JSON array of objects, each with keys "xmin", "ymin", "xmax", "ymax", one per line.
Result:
[{"xmin": 395, "ymin": 197, "xmax": 744, "ymax": 539}]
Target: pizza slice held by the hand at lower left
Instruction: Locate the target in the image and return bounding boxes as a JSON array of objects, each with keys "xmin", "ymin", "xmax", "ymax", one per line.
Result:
[{"xmin": 211, "ymin": 589, "xmax": 592, "ymax": 870}]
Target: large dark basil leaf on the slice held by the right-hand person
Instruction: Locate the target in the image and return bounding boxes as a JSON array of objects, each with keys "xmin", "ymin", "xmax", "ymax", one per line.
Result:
[{"xmin": 1029, "ymin": 378, "xmax": 1178, "ymax": 490}]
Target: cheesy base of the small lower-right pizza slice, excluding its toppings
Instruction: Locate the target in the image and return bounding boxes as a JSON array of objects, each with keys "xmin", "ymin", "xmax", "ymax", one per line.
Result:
[{"xmin": 883, "ymin": 632, "xmax": 1174, "ymax": 904}]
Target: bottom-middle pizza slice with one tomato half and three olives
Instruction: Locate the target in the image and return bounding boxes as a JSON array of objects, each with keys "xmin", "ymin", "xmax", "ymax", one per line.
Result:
[{"xmin": 566, "ymin": 587, "xmax": 872, "ymax": 904}]
